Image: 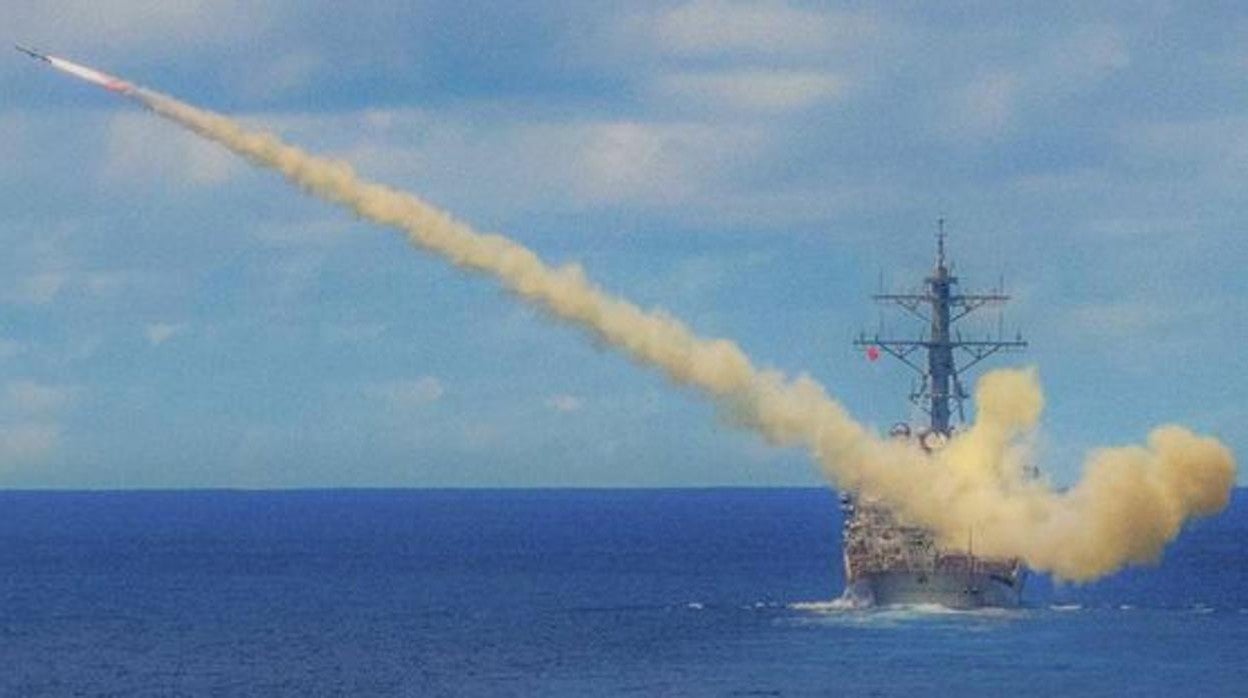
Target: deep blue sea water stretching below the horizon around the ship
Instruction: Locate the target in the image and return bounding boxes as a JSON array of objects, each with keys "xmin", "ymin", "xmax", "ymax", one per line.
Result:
[{"xmin": 0, "ymin": 489, "xmax": 1248, "ymax": 697}]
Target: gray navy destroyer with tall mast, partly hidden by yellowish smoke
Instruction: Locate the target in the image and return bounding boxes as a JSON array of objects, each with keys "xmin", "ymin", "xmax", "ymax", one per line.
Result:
[{"xmin": 841, "ymin": 227, "xmax": 1027, "ymax": 609}]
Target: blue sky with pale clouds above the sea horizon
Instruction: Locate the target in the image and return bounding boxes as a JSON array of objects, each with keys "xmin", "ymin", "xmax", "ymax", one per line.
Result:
[{"xmin": 0, "ymin": 0, "xmax": 1248, "ymax": 488}]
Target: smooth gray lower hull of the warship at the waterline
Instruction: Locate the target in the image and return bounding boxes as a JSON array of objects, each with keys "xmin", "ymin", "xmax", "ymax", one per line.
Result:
[{"xmin": 845, "ymin": 571, "xmax": 1022, "ymax": 609}]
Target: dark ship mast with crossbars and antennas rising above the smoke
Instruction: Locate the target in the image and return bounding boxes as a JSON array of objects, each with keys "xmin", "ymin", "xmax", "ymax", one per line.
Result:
[{"xmin": 854, "ymin": 217, "xmax": 1027, "ymax": 436}]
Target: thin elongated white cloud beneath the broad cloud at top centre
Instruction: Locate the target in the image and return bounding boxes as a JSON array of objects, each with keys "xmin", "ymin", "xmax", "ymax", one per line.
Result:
[{"xmin": 659, "ymin": 69, "xmax": 846, "ymax": 111}]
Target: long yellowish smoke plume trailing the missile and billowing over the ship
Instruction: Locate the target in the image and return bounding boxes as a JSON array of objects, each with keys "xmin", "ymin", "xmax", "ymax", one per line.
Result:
[{"xmin": 24, "ymin": 54, "xmax": 1236, "ymax": 581}]
